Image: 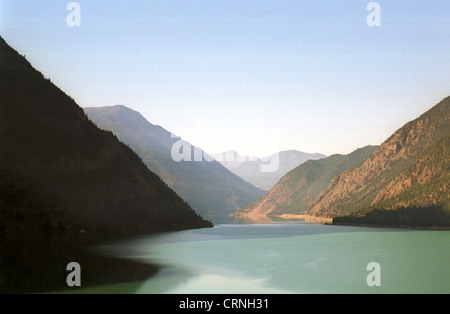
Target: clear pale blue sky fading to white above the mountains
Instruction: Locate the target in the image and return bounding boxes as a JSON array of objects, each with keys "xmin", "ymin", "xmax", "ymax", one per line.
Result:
[{"xmin": 0, "ymin": 0, "xmax": 450, "ymax": 157}]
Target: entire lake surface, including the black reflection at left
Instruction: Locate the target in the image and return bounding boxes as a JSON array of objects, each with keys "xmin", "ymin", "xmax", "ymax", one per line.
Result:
[{"xmin": 0, "ymin": 223, "xmax": 450, "ymax": 294}]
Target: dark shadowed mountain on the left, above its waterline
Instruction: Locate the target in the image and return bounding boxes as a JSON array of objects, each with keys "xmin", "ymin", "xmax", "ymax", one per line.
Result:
[{"xmin": 0, "ymin": 38, "xmax": 211, "ymax": 239}]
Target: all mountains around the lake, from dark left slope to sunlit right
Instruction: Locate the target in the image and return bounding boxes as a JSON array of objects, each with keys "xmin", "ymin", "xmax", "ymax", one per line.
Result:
[{"xmin": 0, "ymin": 31, "xmax": 450, "ymax": 244}]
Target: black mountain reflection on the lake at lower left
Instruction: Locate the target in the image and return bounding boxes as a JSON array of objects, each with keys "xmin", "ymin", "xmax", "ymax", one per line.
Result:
[{"xmin": 0, "ymin": 238, "xmax": 159, "ymax": 293}]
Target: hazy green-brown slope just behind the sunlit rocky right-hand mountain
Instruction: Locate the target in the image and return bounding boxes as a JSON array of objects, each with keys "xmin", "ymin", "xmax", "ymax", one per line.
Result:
[{"xmin": 237, "ymin": 146, "xmax": 377, "ymax": 217}]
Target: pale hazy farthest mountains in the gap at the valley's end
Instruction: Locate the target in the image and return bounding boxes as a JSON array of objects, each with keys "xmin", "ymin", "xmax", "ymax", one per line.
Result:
[{"xmin": 213, "ymin": 150, "xmax": 326, "ymax": 191}]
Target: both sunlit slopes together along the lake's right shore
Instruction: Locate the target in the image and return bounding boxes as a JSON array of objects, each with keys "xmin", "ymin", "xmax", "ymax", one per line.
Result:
[{"xmin": 236, "ymin": 97, "xmax": 450, "ymax": 227}]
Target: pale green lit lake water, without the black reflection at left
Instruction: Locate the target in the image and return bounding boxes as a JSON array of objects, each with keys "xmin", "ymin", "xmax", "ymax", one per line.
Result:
[{"xmin": 79, "ymin": 223, "xmax": 450, "ymax": 294}]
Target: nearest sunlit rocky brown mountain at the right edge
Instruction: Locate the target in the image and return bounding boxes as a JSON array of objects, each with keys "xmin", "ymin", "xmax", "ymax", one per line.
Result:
[{"xmin": 307, "ymin": 97, "xmax": 450, "ymax": 225}]
